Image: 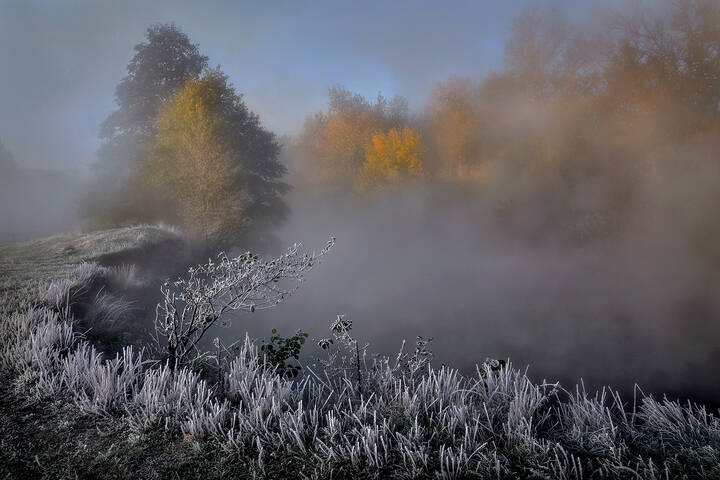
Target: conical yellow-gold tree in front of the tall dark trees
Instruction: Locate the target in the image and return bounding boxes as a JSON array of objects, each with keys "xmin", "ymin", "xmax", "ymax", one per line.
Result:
[{"xmin": 143, "ymin": 71, "xmax": 248, "ymax": 244}]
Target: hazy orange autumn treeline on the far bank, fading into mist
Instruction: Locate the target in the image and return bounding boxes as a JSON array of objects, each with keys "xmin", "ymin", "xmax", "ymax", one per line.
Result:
[{"xmin": 291, "ymin": 0, "xmax": 720, "ymax": 251}]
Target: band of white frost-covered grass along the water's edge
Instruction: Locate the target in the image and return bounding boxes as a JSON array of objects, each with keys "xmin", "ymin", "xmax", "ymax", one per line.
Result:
[{"xmin": 0, "ymin": 228, "xmax": 720, "ymax": 479}]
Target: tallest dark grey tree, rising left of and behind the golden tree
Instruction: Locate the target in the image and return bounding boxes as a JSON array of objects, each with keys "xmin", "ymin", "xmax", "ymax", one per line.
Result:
[{"xmin": 86, "ymin": 24, "xmax": 208, "ymax": 227}]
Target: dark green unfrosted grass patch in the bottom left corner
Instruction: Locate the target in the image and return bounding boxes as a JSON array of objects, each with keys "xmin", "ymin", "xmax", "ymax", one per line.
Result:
[{"xmin": 0, "ymin": 382, "xmax": 256, "ymax": 479}]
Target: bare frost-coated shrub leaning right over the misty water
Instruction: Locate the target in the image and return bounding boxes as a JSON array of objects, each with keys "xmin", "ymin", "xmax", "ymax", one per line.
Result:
[{"xmin": 155, "ymin": 237, "xmax": 335, "ymax": 369}]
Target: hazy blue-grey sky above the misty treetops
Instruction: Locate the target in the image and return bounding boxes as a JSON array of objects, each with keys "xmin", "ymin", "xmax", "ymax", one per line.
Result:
[{"xmin": 0, "ymin": 0, "xmax": 608, "ymax": 175}]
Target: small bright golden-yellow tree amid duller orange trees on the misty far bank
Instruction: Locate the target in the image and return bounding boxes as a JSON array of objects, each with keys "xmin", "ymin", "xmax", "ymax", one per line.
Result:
[{"xmin": 361, "ymin": 125, "xmax": 424, "ymax": 189}]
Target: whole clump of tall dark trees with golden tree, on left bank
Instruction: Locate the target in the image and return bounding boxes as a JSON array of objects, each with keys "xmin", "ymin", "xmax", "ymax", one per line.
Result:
[{"xmin": 87, "ymin": 24, "xmax": 288, "ymax": 244}]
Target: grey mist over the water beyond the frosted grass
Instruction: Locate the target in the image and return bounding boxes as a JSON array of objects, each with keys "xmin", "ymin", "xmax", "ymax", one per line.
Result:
[{"xmin": 240, "ymin": 179, "xmax": 720, "ymax": 402}]
